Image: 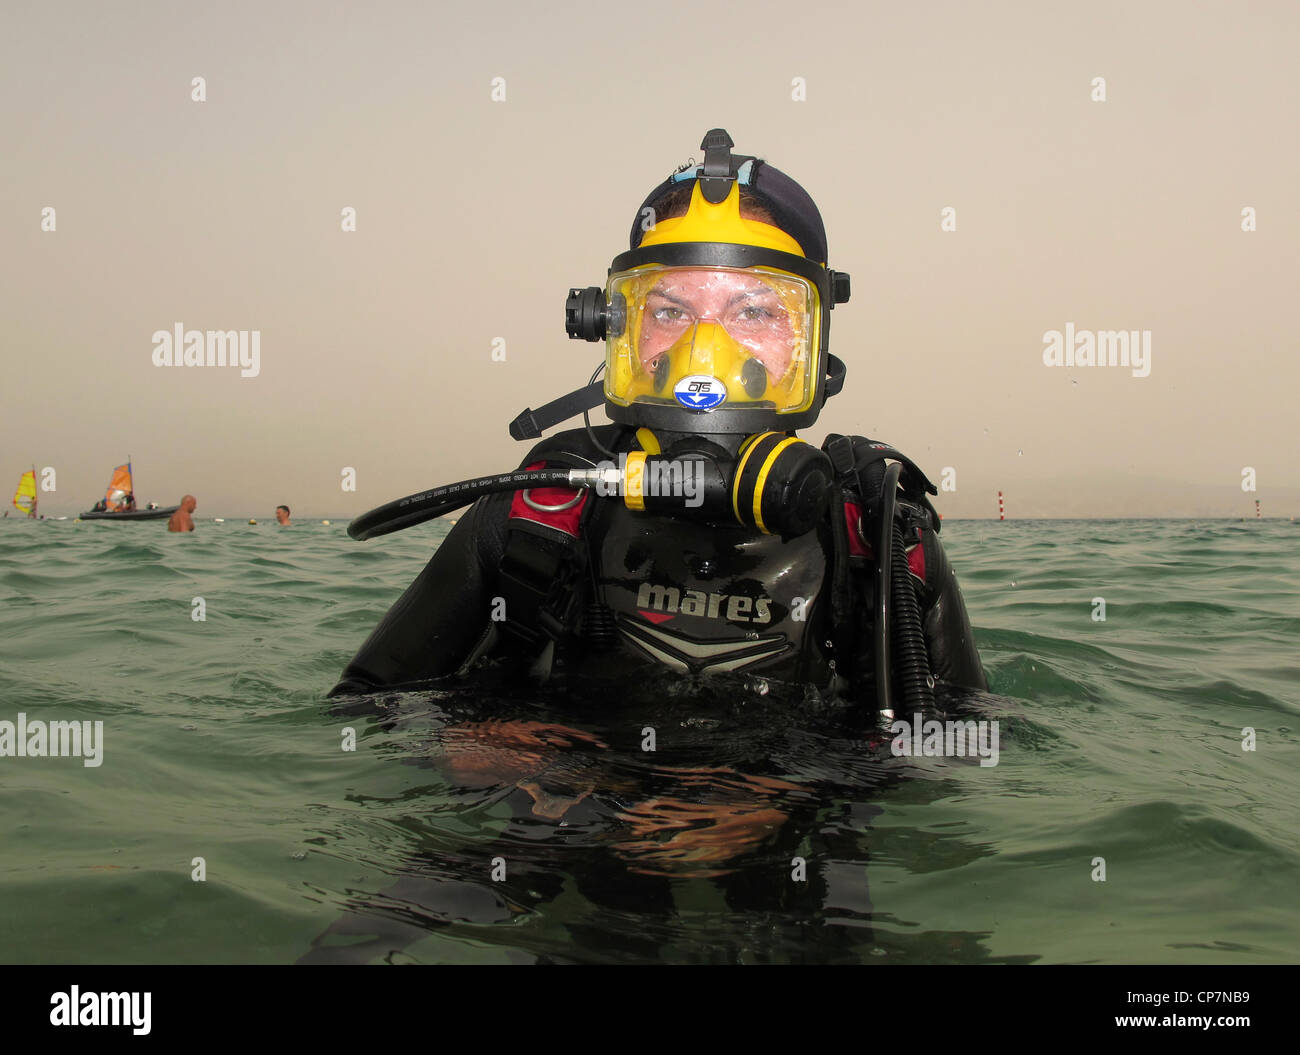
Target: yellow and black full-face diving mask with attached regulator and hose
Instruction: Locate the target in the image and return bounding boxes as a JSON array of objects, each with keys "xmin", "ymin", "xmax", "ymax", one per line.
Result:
[{"xmin": 348, "ymin": 129, "xmax": 868, "ymax": 548}]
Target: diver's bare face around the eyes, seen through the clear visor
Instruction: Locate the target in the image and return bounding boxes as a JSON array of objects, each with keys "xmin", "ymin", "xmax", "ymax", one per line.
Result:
[{"xmin": 640, "ymin": 269, "xmax": 796, "ymax": 383}]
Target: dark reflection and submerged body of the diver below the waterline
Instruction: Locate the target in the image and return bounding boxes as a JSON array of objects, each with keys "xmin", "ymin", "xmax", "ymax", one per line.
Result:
[{"xmin": 300, "ymin": 680, "xmax": 1032, "ymax": 963}]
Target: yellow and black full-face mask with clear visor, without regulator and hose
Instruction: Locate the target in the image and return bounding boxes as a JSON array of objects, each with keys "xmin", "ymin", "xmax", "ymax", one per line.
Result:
[{"xmin": 561, "ymin": 138, "xmax": 849, "ymax": 435}]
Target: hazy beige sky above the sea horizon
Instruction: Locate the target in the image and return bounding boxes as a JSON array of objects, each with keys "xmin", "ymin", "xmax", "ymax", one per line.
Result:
[{"xmin": 0, "ymin": 0, "xmax": 1300, "ymax": 517}]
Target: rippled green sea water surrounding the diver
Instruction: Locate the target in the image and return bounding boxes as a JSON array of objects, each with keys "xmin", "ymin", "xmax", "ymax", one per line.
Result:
[{"xmin": 0, "ymin": 518, "xmax": 1300, "ymax": 964}]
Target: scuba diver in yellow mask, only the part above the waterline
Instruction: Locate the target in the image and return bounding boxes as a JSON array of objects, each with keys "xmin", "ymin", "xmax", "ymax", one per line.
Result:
[{"xmin": 330, "ymin": 129, "xmax": 987, "ymax": 718}]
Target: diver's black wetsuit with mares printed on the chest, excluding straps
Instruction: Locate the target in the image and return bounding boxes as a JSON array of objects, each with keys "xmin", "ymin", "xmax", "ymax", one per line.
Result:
[{"xmin": 332, "ymin": 425, "xmax": 987, "ymax": 696}]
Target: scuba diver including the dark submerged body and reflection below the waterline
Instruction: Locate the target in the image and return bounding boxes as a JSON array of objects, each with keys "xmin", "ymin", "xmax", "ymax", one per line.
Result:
[{"xmin": 302, "ymin": 129, "xmax": 987, "ymax": 963}]
